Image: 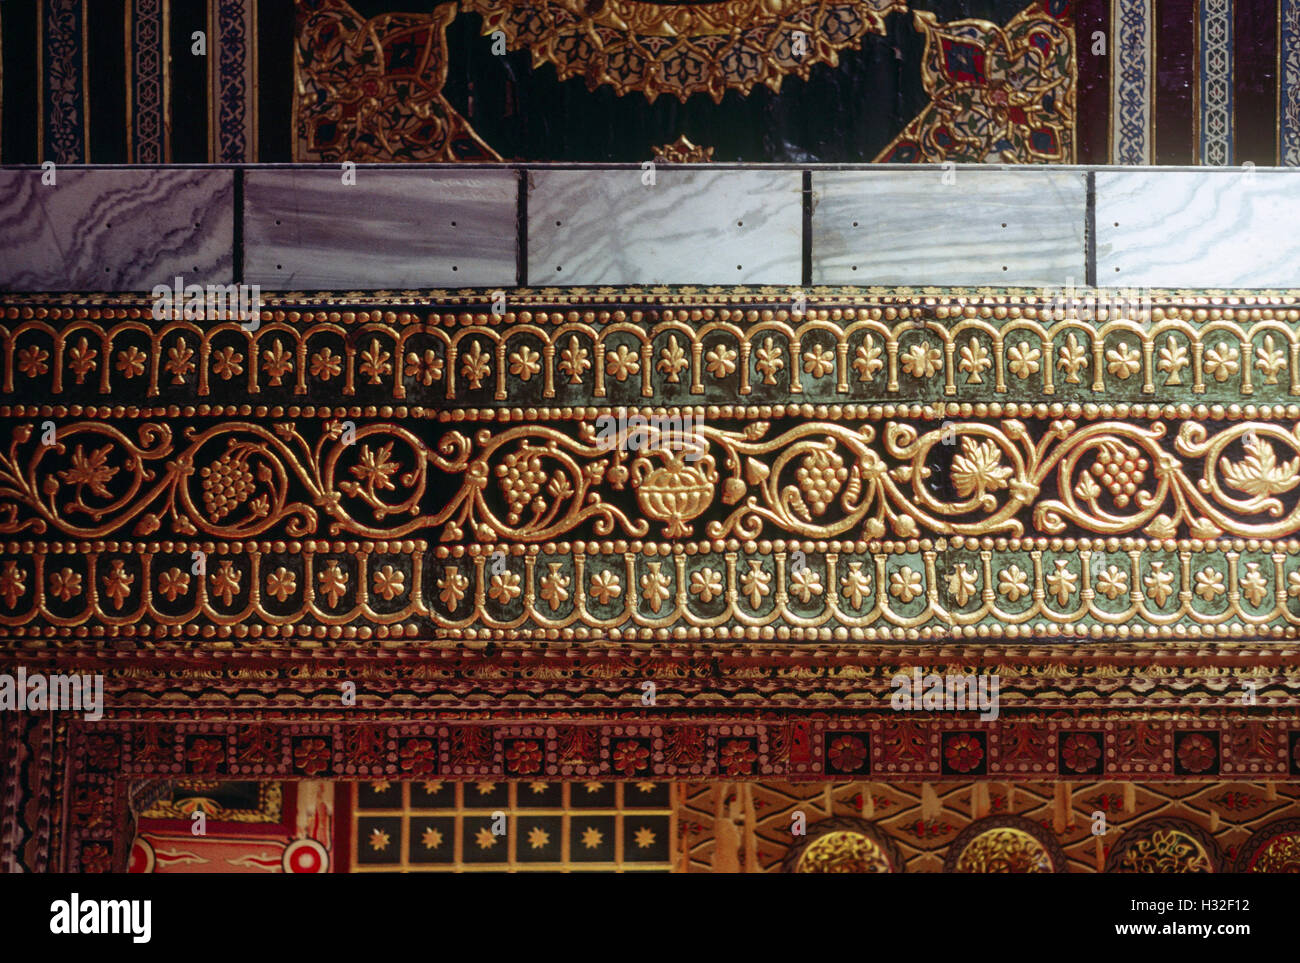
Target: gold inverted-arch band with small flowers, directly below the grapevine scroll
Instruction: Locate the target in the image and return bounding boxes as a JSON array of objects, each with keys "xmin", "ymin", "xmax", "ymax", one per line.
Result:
[{"xmin": 0, "ymin": 537, "xmax": 1300, "ymax": 641}]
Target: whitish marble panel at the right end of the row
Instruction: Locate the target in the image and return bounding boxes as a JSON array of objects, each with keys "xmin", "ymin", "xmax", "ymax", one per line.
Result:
[{"xmin": 1096, "ymin": 168, "xmax": 1300, "ymax": 287}]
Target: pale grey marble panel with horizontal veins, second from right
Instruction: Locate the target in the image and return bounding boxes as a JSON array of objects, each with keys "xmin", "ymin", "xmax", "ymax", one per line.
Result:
[{"xmin": 813, "ymin": 168, "xmax": 1087, "ymax": 286}]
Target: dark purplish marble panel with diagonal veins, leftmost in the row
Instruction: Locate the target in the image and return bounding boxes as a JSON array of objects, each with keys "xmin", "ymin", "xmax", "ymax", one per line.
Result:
[{"xmin": 0, "ymin": 169, "xmax": 234, "ymax": 291}]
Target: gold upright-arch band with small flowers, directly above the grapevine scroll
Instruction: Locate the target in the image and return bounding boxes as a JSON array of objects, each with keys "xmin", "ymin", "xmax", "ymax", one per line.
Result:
[{"xmin": 0, "ymin": 294, "xmax": 1300, "ymax": 404}]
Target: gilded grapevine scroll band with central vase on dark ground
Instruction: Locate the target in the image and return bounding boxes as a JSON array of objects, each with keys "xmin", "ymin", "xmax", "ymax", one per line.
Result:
[{"xmin": 0, "ymin": 420, "xmax": 1300, "ymax": 542}]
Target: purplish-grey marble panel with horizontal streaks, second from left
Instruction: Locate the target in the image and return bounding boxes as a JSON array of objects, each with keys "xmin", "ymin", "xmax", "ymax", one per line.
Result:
[{"xmin": 244, "ymin": 168, "xmax": 519, "ymax": 291}]
